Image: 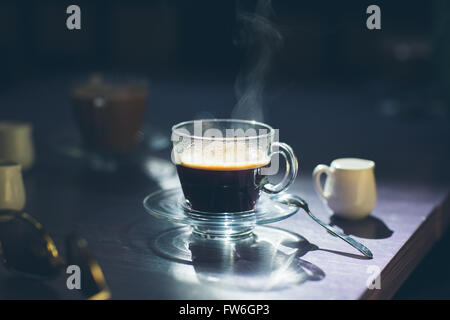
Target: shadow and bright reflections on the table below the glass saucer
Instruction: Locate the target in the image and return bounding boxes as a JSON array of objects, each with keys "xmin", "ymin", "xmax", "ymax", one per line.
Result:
[{"xmin": 153, "ymin": 226, "xmax": 325, "ymax": 291}]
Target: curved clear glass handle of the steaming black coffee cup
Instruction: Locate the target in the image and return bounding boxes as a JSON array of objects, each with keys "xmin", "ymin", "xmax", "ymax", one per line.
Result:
[{"xmin": 262, "ymin": 142, "xmax": 298, "ymax": 194}]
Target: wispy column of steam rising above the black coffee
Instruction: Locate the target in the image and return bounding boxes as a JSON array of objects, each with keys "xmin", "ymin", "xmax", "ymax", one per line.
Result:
[{"xmin": 231, "ymin": 0, "xmax": 283, "ymax": 121}]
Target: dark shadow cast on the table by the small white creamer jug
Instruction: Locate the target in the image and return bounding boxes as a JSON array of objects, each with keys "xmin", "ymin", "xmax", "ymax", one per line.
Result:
[{"xmin": 330, "ymin": 214, "xmax": 394, "ymax": 239}]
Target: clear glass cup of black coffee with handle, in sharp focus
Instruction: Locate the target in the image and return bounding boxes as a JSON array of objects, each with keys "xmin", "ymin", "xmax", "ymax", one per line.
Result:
[{"xmin": 172, "ymin": 119, "xmax": 298, "ymax": 213}]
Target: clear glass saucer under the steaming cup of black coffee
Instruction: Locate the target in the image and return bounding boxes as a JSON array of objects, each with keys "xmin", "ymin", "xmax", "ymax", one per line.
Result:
[{"xmin": 144, "ymin": 188, "xmax": 298, "ymax": 239}]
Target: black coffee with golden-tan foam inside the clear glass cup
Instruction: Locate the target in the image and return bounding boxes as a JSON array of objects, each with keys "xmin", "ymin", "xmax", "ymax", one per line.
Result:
[{"xmin": 177, "ymin": 142, "xmax": 270, "ymax": 212}]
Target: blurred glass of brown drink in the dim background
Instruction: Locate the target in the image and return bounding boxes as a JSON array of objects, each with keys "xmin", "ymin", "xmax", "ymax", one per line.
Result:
[{"xmin": 71, "ymin": 74, "xmax": 149, "ymax": 170}]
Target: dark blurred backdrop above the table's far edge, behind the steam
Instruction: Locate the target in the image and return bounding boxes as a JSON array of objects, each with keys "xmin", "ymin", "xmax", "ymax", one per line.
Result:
[{"xmin": 0, "ymin": 0, "xmax": 449, "ymax": 87}]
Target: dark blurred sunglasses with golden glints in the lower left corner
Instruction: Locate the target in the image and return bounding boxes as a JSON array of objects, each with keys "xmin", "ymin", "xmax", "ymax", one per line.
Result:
[{"xmin": 0, "ymin": 210, "xmax": 111, "ymax": 300}]
